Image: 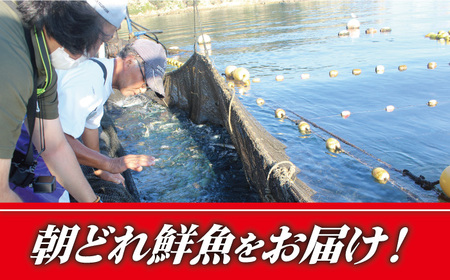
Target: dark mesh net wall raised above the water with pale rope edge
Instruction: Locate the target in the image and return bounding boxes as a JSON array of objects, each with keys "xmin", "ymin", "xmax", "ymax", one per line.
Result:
[{"xmin": 152, "ymin": 52, "xmax": 315, "ymax": 202}]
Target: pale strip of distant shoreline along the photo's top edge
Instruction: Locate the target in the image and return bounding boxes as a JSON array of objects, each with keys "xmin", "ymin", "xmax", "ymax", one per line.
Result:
[{"xmin": 128, "ymin": 0, "xmax": 305, "ymax": 17}]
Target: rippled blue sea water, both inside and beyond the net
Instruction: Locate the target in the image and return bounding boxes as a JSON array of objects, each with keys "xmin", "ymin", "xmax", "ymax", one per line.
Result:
[{"xmin": 118, "ymin": 0, "xmax": 450, "ymax": 202}]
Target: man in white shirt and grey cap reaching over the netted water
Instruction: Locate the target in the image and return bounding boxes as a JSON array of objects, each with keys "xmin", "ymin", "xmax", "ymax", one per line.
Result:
[{"xmin": 57, "ymin": 39, "xmax": 166, "ymax": 186}]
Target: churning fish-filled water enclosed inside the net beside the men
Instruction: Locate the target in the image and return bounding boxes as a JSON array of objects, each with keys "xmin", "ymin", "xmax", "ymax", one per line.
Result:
[{"xmin": 110, "ymin": 97, "xmax": 260, "ymax": 202}]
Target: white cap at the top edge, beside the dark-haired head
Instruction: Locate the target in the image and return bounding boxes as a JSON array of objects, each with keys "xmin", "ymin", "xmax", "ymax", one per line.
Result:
[{"xmin": 86, "ymin": 0, "xmax": 128, "ymax": 28}]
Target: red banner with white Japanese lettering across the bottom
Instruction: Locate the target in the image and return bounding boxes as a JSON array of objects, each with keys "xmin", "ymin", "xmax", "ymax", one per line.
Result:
[{"xmin": 0, "ymin": 203, "xmax": 450, "ymax": 279}]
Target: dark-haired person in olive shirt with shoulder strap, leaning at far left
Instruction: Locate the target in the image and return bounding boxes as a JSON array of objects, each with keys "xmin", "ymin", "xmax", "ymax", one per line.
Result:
[{"xmin": 0, "ymin": 1, "xmax": 124, "ymax": 202}]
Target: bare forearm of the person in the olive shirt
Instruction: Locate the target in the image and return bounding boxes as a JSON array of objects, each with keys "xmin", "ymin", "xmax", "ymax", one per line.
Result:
[{"xmin": 33, "ymin": 118, "xmax": 97, "ymax": 202}]
